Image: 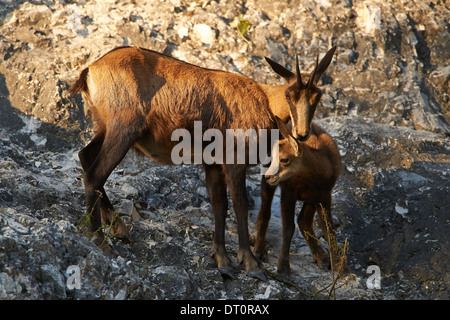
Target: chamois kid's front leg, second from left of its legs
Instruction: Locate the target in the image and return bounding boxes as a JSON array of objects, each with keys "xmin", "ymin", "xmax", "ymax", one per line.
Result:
[{"xmin": 277, "ymin": 187, "xmax": 297, "ymax": 278}]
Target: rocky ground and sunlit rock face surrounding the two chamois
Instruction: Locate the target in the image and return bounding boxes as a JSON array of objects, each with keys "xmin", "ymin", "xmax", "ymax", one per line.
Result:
[{"xmin": 0, "ymin": 0, "xmax": 450, "ymax": 299}]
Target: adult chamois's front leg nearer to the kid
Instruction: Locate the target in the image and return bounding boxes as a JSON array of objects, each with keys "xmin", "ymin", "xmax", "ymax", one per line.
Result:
[{"xmin": 223, "ymin": 164, "xmax": 267, "ymax": 280}]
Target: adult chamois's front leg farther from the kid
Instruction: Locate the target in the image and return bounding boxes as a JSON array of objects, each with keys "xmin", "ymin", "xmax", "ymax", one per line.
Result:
[{"xmin": 205, "ymin": 166, "xmax": 236, "ymax": 279}]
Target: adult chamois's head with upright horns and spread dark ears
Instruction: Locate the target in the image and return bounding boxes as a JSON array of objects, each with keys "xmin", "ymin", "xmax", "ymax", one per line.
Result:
[{"xmin": 266, "ymin": 46, "xmax": 336, "ymax": 141}]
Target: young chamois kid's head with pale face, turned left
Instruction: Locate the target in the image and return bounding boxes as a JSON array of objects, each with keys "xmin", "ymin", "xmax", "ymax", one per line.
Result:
[{"xmin": 265, "ymin": 117, "xmax": 304, "ymax": 185}]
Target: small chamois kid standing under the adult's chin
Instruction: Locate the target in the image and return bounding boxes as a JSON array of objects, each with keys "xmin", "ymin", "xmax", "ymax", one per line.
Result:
[{"xmin": 255, "ymin": 119, "xmax": 346, "ymax": 277}]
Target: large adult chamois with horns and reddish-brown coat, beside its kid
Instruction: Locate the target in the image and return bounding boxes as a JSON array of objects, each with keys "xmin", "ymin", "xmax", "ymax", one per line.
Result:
[{"xmin": 69, "ymin": 47, "xmax": 335, "ymax": 279}]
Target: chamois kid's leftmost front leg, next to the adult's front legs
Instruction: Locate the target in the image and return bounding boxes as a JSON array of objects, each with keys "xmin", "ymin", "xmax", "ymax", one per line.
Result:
[{"xmin": 255, "ymin": 176, "xmax": 276, "ymax": 262}]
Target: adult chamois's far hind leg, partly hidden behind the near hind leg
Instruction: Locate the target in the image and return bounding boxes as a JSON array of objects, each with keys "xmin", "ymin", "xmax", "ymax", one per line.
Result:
[{"xmin": 78, "ymin": 130, "xmax": 132, "ymax": 243}]
